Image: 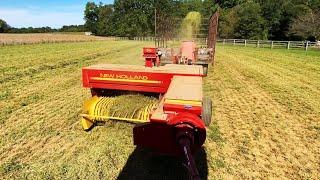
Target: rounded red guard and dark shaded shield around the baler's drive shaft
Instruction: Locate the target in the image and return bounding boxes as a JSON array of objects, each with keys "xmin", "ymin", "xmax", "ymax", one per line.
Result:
[{"xmin": 133, "ymin": 113, "xmax": 206, "ymax": 155}]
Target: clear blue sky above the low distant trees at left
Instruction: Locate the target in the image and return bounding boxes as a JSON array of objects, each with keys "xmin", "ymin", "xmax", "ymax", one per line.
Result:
[{"xmin": 0, "ymin": 0, "xmax": 113, "ymax": 28}]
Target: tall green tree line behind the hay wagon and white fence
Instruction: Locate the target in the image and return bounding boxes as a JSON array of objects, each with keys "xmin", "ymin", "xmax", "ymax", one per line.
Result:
[{"xmin": 84, "ymin": 0, "xmax": 320, "ymax": 40}]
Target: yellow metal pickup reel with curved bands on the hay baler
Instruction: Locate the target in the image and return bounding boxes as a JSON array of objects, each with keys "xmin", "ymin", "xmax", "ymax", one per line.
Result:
[{"xmin": 80, "ymin": 96, "xmax": 158, "ymax": 130}]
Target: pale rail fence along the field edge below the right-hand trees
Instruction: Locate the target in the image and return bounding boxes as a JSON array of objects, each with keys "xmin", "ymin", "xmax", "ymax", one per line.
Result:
[{"xmin": 217, "ymin": 39, "xmax": 320, "ymax": 51}]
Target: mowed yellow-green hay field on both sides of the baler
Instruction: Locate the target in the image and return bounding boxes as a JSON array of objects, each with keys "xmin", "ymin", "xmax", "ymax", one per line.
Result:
[{"xmin": 0, "ymin": 41, "xmax": 320, "ymax": 179}]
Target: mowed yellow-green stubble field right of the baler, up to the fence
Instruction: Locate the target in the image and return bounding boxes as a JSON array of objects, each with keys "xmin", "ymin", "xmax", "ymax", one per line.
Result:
[{"xmin": 206, "ymin": 47, "xmax": 320, "ymax": 179}]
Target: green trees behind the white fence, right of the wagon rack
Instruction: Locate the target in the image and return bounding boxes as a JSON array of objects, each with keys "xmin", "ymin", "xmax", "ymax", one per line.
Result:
[{"xmin": 219, "ymin": 0, "xmax": 320, "ymax": 41}]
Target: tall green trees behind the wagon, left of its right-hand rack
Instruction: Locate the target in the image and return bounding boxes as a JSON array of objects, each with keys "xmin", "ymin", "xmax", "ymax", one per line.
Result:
[{"xmin": 84, "ymin": 0, "xmax": 217, "ymax": 37}]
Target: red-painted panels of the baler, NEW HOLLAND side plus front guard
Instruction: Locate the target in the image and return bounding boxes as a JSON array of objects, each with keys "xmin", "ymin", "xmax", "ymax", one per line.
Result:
[{"xmin": 82, "ymin": 66, "xmax": 206, "ymax": 155}]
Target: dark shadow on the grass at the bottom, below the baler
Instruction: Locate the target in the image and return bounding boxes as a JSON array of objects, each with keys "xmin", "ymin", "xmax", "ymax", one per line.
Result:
[{"xmin": 117, "ymin": 148, "xmax": 208, "ymax": 180}]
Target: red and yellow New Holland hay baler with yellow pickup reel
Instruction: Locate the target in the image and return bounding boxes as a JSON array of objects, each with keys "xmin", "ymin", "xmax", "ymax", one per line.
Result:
[{"xmin": 81, "ymin": 63, "xmax": 212, "ymax": 179}]
